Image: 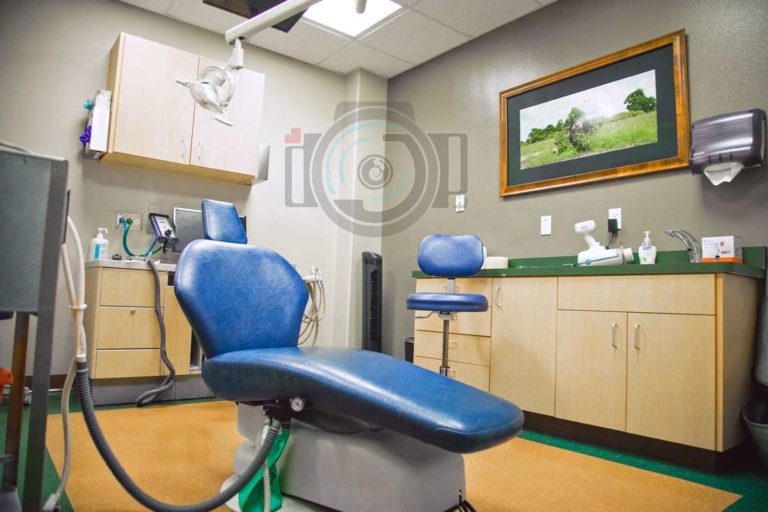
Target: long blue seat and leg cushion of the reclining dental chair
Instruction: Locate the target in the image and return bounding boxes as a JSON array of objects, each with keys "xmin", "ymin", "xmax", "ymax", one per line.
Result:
[{"xmin": 203, "ymin": 347, "xmax": 523, "ymax": 453}]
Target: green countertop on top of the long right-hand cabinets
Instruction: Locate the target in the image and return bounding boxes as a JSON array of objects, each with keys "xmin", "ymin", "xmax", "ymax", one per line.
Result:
[{"xmin": 412, "ymin": 247, "xmax": 766, "ymax": 279}]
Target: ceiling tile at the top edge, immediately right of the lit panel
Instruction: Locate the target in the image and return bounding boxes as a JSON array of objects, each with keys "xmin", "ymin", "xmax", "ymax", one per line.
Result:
[{"xmin": 413, "ymin": 0, "xmax": 541, "ymax": 37}]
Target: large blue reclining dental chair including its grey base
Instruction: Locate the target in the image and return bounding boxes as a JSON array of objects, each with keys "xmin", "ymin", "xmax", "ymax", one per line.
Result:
[{"xmin": 174, "ymin": 201, "xmax": 523, "ymax": 511}]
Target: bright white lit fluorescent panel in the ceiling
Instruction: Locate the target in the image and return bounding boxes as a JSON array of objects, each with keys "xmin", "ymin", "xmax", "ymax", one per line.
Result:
[{"xmin": 304, "ymin": 0, "xmax": 401, "ymax": 37}]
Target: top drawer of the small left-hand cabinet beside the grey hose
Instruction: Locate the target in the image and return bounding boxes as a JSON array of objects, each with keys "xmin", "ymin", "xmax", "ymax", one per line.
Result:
[{"xmin": 101, "ymin": 268, "xmax": 168, "ymax": 307}]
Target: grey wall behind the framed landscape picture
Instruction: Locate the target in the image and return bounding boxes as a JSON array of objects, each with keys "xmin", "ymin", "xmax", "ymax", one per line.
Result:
[{"xmin": 382, "ymin": 0, "xmax": 768, "ymax": 354}]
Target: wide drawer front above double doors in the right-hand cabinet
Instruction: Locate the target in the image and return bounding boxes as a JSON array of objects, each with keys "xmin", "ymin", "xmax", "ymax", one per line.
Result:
[{"xmin": 557, "ymin": 274, "xmax": 715, "ymax": 315}]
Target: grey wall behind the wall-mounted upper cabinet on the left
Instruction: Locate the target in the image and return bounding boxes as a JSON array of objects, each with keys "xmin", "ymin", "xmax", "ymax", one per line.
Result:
[{"xmin": 0, "ymin": 0, "xmax": 349, "ymax": 374}]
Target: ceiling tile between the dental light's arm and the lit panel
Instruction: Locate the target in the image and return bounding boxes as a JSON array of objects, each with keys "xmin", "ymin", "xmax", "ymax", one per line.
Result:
[{"xmin": 248, "ymin": 20, "xmax": 352, "ymax": 64}]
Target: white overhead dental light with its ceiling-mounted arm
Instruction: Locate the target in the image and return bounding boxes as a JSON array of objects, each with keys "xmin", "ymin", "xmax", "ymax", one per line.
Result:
[{"xmin": 181, "ymin": 0, "xmax": 366, "ymax": 126}]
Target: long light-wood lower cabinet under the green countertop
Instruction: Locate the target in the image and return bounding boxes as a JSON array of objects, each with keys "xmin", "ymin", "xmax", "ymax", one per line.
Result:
[{"xmin": 415, "ymin": 273, "xmax": 760, "ymax": 452}]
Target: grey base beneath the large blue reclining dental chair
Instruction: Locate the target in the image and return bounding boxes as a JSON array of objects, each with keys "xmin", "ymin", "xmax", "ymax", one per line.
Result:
[{"xmin": 228, "ymin": 405, "xmax": 466, "ymax": 512}]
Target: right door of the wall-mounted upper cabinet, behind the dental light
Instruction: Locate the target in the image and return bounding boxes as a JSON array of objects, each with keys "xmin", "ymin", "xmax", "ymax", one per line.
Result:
[{"xmin": 190, "ymin": 57, "xmax": 264, "ymax": 174}]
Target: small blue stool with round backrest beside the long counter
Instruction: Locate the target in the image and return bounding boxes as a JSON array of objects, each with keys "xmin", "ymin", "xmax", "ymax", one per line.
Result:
[{"xmin": 406, "ymin": 235, "xmax": 488, "ymax": 376}]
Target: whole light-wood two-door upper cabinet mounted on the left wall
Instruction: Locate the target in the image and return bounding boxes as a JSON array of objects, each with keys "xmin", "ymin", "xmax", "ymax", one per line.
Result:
[{"xmin": 103, "ymin": 34, "xmax": 264, "ymax": 183}]
